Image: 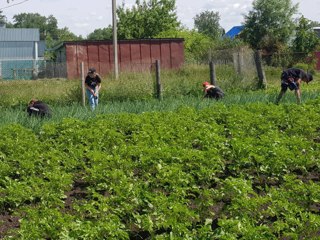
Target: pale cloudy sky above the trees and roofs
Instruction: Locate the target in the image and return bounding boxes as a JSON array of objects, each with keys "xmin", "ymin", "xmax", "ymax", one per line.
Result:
[{"xmin": 0, "ymin": 0, "xmax": 320, "ymax": 36}]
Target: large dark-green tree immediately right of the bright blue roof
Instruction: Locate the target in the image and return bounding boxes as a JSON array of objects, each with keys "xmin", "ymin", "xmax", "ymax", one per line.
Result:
[{"xmin": 240, "ymin": 0, "xmax": 298, "ymax": 53}]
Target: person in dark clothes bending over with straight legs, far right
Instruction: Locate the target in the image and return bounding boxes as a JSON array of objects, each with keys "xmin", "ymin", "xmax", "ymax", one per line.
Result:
[{"xmin": 276, "ymin": 68, "xmax": 313, "ymax": 104}]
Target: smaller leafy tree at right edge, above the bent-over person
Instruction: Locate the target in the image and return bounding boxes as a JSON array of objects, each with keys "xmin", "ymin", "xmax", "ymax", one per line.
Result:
[{"xmin": 292, "ymin": 16, "xmax": 319, "ymax": 54}]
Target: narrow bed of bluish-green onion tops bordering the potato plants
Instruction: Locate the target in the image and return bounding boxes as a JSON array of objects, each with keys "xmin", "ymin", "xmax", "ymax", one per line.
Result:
[{"xmin": 0, "ymin": 89, "xmax": 319, "ymax": 132}]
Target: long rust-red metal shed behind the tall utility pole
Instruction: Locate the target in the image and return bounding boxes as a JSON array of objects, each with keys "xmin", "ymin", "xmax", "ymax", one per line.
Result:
[{"xmin": 56, "ymin": 38, "xmax": 184, "ymax": 79}]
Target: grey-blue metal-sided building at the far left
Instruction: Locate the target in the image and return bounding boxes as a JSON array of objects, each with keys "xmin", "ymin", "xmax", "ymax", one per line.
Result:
[{"xmin": 0, "ymin": 24, "xmax": 45, "ymax": 79}]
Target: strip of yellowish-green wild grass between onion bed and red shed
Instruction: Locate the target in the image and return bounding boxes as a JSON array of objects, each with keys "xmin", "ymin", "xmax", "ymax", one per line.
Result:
[{"xmin": 0, "ymin": 65, "xmax": 284, "ymax": 106}]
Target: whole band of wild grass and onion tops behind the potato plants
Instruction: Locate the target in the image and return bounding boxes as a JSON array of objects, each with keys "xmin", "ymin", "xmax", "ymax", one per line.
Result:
[{"xmin": 0, "ymin": 65, "xmax": 320, "ymax": 131}]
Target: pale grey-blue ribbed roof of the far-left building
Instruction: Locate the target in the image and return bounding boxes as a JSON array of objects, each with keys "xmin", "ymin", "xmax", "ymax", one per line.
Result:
[{"xmin": 0, "ymin": 28, "xmax": 40, "ymax": 42}]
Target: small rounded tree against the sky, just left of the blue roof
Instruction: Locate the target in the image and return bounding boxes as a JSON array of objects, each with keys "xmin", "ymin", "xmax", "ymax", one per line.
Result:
[{"xmin": 194, "ymin": 11, "xmax": 224, "ymax": 39}]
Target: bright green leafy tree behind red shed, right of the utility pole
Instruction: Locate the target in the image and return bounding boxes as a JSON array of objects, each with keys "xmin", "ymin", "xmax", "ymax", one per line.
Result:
[{"xmin": 117, "ymin": 0, "xmax": 180, "ymax": 39}]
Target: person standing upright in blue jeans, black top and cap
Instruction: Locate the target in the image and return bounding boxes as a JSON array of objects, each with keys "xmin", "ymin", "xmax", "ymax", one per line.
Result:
[{"xmin": 85, "ymin": 68, "xmax": 101, "ymax": 110}]
